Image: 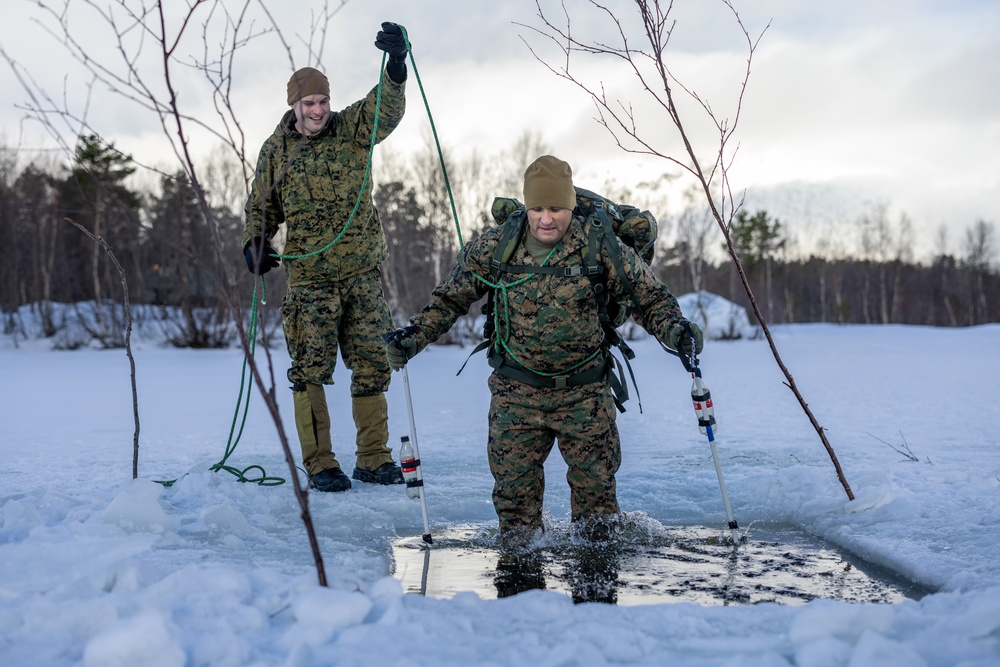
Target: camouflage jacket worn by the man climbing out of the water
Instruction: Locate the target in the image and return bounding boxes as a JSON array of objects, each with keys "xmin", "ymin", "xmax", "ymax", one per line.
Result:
[{"xmin": 411, "ymin": 216, "xmax": 682, "ymax": 375}]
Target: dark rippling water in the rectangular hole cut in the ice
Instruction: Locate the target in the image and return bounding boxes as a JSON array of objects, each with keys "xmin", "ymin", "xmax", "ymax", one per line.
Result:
[{"xmin": 393, "ymin": 524, "xmax": 929, "ymax": 605}]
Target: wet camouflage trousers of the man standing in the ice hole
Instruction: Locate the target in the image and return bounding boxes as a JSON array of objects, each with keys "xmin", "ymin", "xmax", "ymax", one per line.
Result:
[{"xmin": 487, "ymin": 373, "xmax": 621, "ymax": 532}]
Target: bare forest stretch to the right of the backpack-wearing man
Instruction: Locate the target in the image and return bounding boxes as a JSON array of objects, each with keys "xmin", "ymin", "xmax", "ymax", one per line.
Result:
[{"xmin": 660, "ymin": 205, "xmax": 1000, "ymax": 327}]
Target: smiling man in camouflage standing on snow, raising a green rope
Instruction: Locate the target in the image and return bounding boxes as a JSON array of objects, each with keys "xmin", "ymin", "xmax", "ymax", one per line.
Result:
[{"xmin": 242, "ymin": 23, "xmax": 408, "ymax": 491}]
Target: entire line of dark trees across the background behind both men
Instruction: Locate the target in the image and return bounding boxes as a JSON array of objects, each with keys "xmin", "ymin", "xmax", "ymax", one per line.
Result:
[{"xmin": 0, "ymin": 134, "xmax": 1000, "ymax": 348}]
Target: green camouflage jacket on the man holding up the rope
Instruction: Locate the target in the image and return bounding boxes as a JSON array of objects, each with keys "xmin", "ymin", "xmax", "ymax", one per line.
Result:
[{"xmin": 242, "ymin": 70, "xmax": 405, "ymax": 285}]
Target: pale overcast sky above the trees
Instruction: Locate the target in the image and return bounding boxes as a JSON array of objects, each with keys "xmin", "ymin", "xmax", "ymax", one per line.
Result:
[{"xmin": 0, "ymin": 0, "xmax": 1000, "ymax": 254}]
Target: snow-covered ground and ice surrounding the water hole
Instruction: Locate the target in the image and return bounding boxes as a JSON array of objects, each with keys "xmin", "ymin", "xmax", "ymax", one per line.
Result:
[{"xmin": 0, "ymin": 302, "xmax": 1000, "ymax": 667}]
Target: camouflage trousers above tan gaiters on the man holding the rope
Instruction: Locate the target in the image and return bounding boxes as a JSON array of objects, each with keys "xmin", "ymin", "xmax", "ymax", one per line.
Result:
[{"xmin": 281, "ymin": 269, "xmax": 392, "ymax": 397}]
